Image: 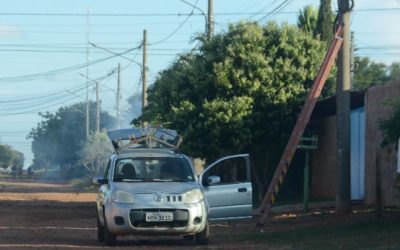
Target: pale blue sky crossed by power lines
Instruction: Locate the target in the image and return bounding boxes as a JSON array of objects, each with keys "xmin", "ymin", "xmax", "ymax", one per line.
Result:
[{"xmin": 0, "ymin": 0, "xmax": 400, "ymax": 167}]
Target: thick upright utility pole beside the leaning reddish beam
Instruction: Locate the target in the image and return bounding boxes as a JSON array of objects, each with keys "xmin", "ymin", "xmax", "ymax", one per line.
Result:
[{"xmin": 336, "ymin": 0, "xmax": 350, "ymax": 215}]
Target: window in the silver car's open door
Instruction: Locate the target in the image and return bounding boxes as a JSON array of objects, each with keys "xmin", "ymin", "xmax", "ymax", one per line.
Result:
[{"xmin": 203, "ymin": 157, "xmax": 247, "ymax": 185}]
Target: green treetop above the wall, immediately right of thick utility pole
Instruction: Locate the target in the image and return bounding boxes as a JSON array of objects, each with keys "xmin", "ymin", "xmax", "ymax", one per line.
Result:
[{"xmin": 353, "ymin": 57, "xmax": 389, "ymax": 90}]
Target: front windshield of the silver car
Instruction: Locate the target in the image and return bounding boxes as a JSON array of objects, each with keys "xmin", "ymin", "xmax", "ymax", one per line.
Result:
[{"xmin": 113, "ymin": 157, "xmax": 194, "ymax": 182}]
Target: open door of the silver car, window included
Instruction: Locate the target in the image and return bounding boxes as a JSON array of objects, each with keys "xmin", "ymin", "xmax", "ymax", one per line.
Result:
[{"xmin": 200, "ymin": 154, "xmax": 252, "ymax": 221}]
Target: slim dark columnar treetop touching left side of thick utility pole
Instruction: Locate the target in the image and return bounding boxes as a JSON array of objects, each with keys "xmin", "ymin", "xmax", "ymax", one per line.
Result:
[{"xmin": 317, "ymin": 0, "xmax": 335, "ymax": 43}]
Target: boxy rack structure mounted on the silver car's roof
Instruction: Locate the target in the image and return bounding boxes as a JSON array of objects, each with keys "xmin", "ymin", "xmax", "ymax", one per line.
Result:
[{"xmin": 107, "ymin": 127, "xmax": 182, "ymax": 153}]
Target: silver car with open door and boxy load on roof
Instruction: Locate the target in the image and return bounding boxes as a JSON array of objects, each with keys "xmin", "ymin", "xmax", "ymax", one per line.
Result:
[{"xmin": 94, "ymin": 129, "xmax": 252, "ymax": 245}]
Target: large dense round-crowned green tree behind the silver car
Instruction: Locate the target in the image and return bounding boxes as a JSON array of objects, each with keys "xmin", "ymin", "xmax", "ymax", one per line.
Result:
[{"xmin": 135, "ymin": 23, "xmax": 325, "ymax": 201}]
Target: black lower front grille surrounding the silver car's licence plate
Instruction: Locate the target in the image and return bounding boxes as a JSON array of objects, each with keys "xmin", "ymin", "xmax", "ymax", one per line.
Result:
[{"xmin": 129, "ymin": 209, "xmax": 189, "ymax": 228}]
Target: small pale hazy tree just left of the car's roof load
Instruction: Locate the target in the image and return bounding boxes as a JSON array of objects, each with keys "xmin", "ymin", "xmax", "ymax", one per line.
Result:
[{"xmin": 81, "ymin": 132, "xmax": 113, "ymax": 174}]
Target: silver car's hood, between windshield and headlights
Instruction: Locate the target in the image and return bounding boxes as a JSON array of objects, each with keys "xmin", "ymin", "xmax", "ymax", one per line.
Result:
[{"xmin": 114, "ymin": 182, "xmax": 200, "ymax": 194}]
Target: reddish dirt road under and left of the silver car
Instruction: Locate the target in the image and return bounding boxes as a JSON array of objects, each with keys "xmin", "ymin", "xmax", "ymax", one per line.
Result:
[{"xmin": 0, "ymin": 179, "xmax": 262, "ymax": 249}]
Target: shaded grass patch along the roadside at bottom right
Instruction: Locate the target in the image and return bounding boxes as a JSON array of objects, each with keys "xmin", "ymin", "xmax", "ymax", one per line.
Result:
[{"xmin": 220, "ymin": 214, "xmax": 400, "ymax": 249}]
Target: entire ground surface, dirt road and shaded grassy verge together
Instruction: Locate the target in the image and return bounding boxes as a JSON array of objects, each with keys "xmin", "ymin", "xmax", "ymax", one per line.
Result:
[{"xmin": 0, "ymin": 179, "xmax": 400, "ymax": 249}]
